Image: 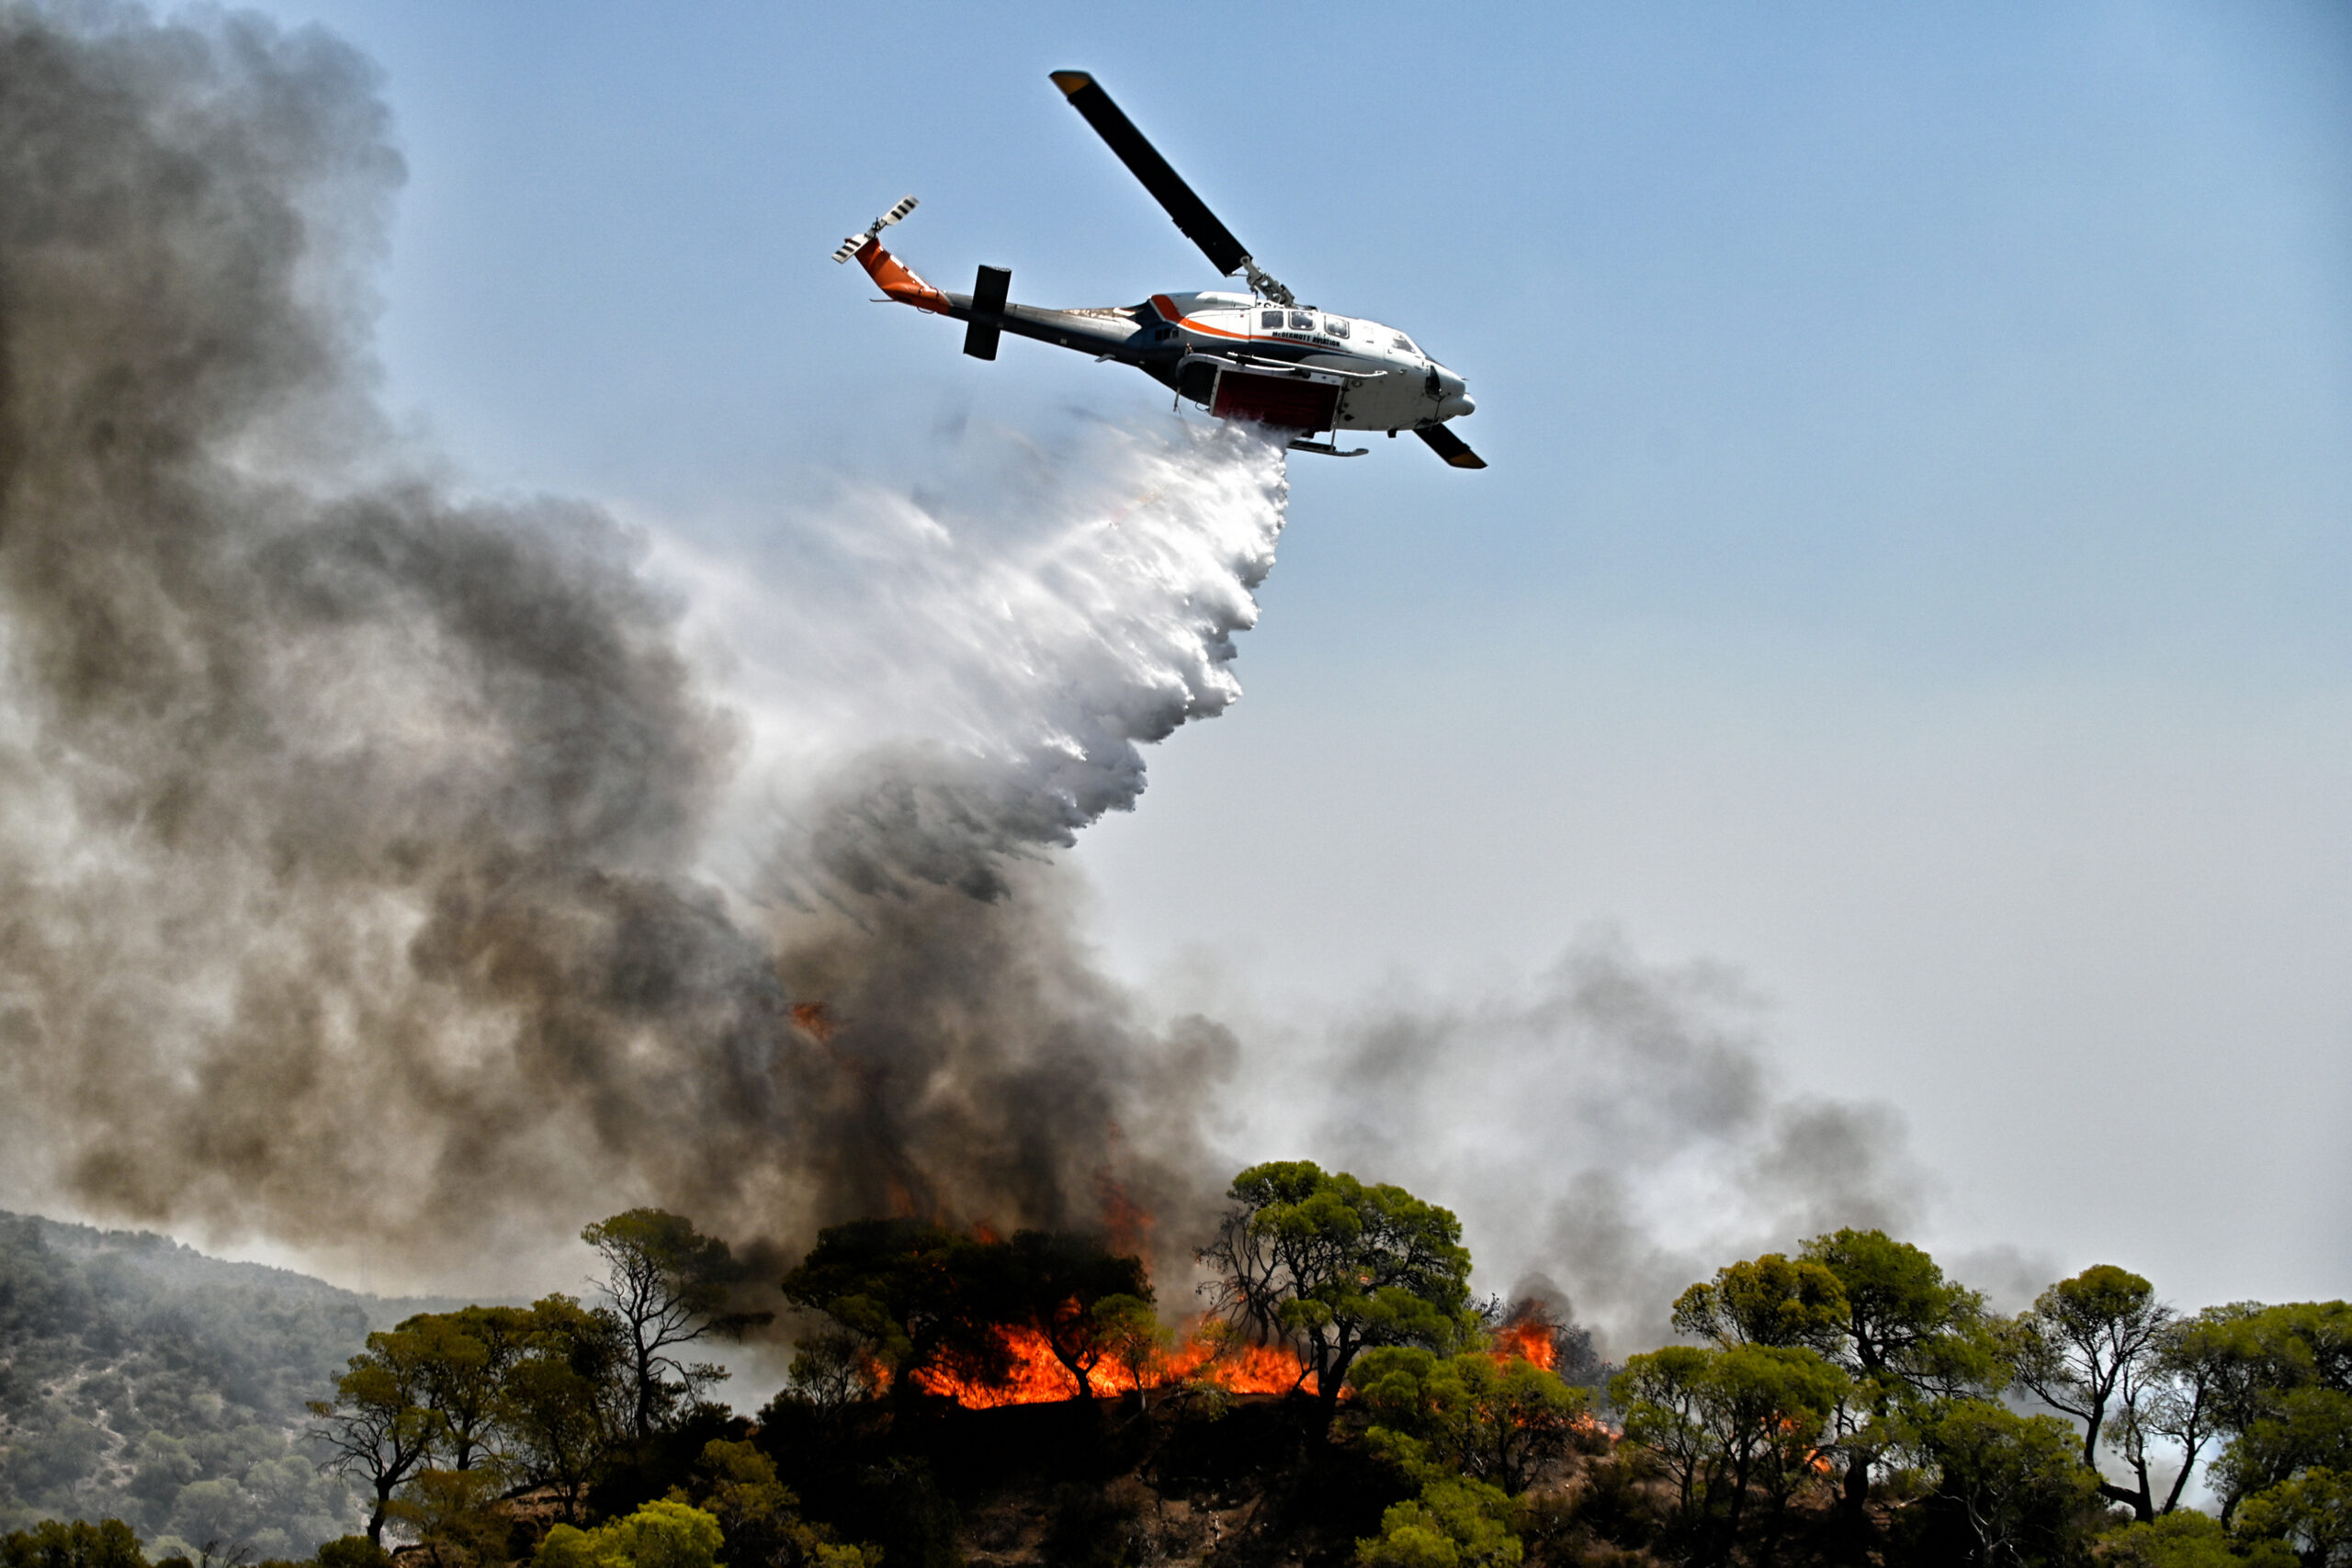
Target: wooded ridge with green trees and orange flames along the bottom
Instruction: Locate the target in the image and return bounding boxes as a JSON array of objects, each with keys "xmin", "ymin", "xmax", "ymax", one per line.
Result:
[{"xmin": 0, "ymin": 1161, "xmax": 2352, "ymax": 1568}]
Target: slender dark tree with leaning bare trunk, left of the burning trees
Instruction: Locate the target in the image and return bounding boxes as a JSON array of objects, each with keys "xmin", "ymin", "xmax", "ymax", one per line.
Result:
[{"xmin": 581, "ymin": 1208, "xmax": 776, "ymax": 1441}]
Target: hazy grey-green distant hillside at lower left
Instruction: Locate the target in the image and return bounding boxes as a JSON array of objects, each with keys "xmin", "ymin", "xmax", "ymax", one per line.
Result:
[{"xmin": 0, "ymin": 1213, "xmax": 458, "ymax": 1556}]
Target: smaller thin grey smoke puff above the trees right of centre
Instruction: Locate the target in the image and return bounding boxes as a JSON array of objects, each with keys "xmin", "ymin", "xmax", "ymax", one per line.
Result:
[{"xmin": 1251, "ymin": 933, "xmax": 1927, "ymax": 1357}]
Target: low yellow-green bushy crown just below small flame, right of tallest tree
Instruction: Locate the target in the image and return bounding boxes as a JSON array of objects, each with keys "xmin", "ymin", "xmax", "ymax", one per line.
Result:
[{"xmin": 1348, "ymin": 1345, "xmax": 1590, "ymax": 1495}]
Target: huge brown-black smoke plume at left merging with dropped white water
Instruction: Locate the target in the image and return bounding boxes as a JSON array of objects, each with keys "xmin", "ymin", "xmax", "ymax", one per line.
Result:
[{"xmin": 0, "ymin": 5, "xmax": 1282, "ymax": 1277}]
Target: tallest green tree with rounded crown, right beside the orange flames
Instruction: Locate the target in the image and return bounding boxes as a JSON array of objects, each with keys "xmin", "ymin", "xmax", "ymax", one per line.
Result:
[{"xmin": 1200, "ymin": 1159, "xmax": 1470, "ymax": 1429}]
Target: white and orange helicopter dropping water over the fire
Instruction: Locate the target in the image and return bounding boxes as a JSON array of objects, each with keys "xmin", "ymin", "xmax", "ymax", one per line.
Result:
[{"xmin": 832, "ymin": 71, "xmax": 1487, "ymax": 468}]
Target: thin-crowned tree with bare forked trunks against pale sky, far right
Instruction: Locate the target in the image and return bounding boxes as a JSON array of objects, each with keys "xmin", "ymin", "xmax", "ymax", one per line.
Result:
[{"xmin": 2013, "ymin": 1262, "xmax": 2173, "ymax": 1521}]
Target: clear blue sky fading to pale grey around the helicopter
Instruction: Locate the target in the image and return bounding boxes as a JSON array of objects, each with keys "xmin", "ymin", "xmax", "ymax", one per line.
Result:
[{"xmin": 248, "ymin": 0, "xmax": 2352, "ymax": 1304}]
